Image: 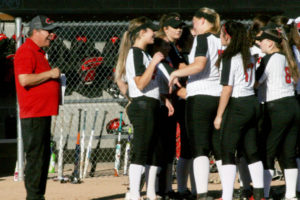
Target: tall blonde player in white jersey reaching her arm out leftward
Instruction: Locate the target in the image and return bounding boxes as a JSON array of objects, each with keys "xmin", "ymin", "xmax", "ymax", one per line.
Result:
[{"xmin": 169, "ymin": 8, "xmax": 221, "ymax": 199}]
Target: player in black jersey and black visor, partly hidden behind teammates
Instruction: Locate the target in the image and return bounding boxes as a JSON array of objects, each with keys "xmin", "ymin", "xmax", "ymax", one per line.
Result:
[{"xmin": 157, "ymin": 13, "xmax": 195, "ymax": 197}]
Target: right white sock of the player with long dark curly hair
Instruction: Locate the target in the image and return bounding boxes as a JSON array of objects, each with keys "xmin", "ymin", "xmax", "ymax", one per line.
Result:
[{"xmin": 248, "ymin": 161, "xmax": 264, "ymax": 188}]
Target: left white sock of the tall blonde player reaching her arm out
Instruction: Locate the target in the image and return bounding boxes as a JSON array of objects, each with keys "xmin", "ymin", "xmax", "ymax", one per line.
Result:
[{"xmin": 194, "ymin": 156, "xmax": 209, "ymax": 194}]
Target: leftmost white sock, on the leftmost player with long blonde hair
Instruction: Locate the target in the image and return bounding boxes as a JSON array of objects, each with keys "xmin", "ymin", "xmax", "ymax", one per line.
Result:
[{"xmin": 129, "ymin": 164, "xmax": 145, "ymax": 200}]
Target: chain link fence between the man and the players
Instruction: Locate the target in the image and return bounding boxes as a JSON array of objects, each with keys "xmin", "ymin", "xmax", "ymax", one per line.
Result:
[{"xmin": 23, "ymin": 22, "xmax": 130, "ymax": 177}]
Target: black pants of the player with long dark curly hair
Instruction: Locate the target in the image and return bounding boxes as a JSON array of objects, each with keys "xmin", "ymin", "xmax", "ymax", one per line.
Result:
[{"xmin": 221, "ymin": 96, "xmax": 260, "ymax": 165}]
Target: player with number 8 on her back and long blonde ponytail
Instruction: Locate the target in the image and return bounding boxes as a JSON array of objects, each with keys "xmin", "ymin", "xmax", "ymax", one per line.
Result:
[{"xmin": 256, "ymin": 24, "xmax": 300, "ymax": 199}]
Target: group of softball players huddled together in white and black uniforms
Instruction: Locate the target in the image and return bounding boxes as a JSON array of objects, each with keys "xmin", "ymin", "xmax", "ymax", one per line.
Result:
[{"xmin": 115, "ymin": 5, "xmax": 300, "ymax": 200}]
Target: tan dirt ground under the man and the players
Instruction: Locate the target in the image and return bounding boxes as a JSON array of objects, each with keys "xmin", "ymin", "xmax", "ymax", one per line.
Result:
[{"xmin": 0, "ymin": 171, "xmax": 284, "ymax": 200}]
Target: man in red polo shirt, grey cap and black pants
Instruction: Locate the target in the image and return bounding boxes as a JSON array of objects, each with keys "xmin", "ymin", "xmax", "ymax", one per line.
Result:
[{"xmin": 14, "ymin": 16, "xmax": 60, "ymax": 200}]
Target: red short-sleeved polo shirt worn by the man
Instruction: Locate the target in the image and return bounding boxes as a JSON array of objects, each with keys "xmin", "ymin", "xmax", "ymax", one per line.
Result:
[{"xmin": 14, "ymin": 38, "xmax": 60, "ymax": 118}]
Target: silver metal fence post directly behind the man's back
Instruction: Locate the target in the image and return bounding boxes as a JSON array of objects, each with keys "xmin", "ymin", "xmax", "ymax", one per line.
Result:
[{"xmin": 15, "ymin": 17, "xmax": 24, "ymax": 181}]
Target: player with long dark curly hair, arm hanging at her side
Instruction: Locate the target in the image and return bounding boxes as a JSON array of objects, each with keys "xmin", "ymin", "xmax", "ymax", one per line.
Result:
[{"xmin": 214, "ymin": 21, "xmax": 263, "ymax": 200}]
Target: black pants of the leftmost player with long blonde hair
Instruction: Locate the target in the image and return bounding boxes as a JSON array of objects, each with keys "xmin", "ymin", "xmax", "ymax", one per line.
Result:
[{"xmin": 128, "ymin": 96, "xmax": 160, "ymax": 165}]
